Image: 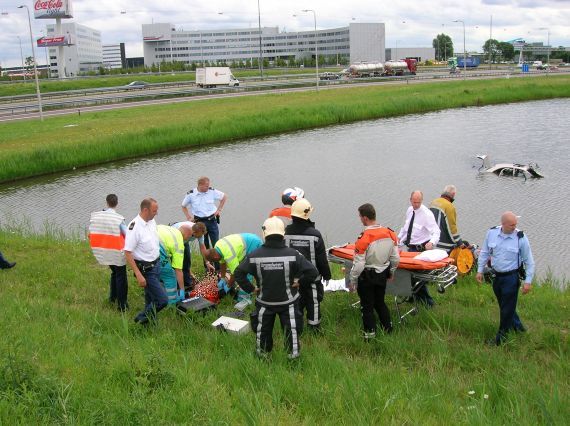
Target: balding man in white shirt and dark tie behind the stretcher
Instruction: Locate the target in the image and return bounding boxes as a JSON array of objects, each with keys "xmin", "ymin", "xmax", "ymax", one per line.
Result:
[{"xmin": 398, "ymin": 190, "xmax": 440, "ymax": 308}]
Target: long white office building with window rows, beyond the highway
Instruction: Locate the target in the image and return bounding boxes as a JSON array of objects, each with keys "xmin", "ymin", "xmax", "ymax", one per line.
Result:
[{"xmin": 142, "ymin": 23, "xmax": 385, "ymax": 66}]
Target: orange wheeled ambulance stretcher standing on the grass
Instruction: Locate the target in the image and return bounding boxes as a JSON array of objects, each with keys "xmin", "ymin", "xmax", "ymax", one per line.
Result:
[{"xmin": 327, "ymin": 244, "xmax": 457, "ymax": 323}]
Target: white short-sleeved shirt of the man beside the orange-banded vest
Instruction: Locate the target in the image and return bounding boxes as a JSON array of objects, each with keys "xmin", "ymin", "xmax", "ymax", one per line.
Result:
[{"xmin": 124, "ymin": 215, "xmax": 160, "ymax": 262}]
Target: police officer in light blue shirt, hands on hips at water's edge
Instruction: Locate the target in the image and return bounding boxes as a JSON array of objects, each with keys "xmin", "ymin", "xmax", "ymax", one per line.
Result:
[{"xmin": 182, "ymin": 176, "xmax": 228, "ymax": 255}]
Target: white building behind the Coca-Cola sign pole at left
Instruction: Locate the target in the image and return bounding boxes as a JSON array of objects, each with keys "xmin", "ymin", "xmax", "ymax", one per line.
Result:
[{"xmin": 46, "ymin": 22, "xmax": 103, "ymax": 77}]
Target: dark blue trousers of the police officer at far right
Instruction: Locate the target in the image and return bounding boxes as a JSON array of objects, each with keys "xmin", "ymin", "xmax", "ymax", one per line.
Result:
[{"xmin": 493, "ymin": 271, "xmax": 524, "ymax": 343}]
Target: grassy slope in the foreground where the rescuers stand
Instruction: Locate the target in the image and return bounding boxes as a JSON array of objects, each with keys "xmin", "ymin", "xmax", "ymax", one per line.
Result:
[{"xmin": 0, "ymin": 232, "xmax": 570, "ymax": 425}]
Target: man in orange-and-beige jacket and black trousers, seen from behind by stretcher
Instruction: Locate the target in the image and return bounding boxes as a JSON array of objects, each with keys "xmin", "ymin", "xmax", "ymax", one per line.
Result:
[{"xmin": 349, "ymin": 203, "xmax": 400, "ymax": 341}]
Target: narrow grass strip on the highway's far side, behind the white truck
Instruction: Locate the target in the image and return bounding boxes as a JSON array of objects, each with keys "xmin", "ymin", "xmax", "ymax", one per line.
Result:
[{"xmin": 0, "ymin": 68, "xmax": 320, "ymax": 97}]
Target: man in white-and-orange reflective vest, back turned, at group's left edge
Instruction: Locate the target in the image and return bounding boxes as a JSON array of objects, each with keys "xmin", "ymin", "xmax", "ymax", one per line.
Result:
[{"xmin": 89, "ymin": 194, "xmax": 129, "ymax": 312}]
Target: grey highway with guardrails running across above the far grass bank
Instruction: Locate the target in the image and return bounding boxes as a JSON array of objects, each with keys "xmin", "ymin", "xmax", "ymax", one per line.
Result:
[{"xmin": 0, "ymin": 68, "xmax": 570, "ymax": 122}]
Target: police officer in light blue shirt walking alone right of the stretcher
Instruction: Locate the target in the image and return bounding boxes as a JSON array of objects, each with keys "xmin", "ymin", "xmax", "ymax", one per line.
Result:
[{"xmin": 476, "ymin": 211, "xmax": 534, "ymax": 346}]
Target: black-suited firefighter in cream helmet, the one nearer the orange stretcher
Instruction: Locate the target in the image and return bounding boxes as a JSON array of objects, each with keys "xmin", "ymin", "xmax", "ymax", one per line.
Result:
[{"xmin": 285, "ymin": 198, "xmax": 331, "ymax": 331}]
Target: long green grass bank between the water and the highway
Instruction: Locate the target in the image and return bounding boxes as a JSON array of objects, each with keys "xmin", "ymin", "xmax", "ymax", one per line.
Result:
[{"xmin": 0, "ymin": 76, "xmax": 570, "ymax": 182}]
